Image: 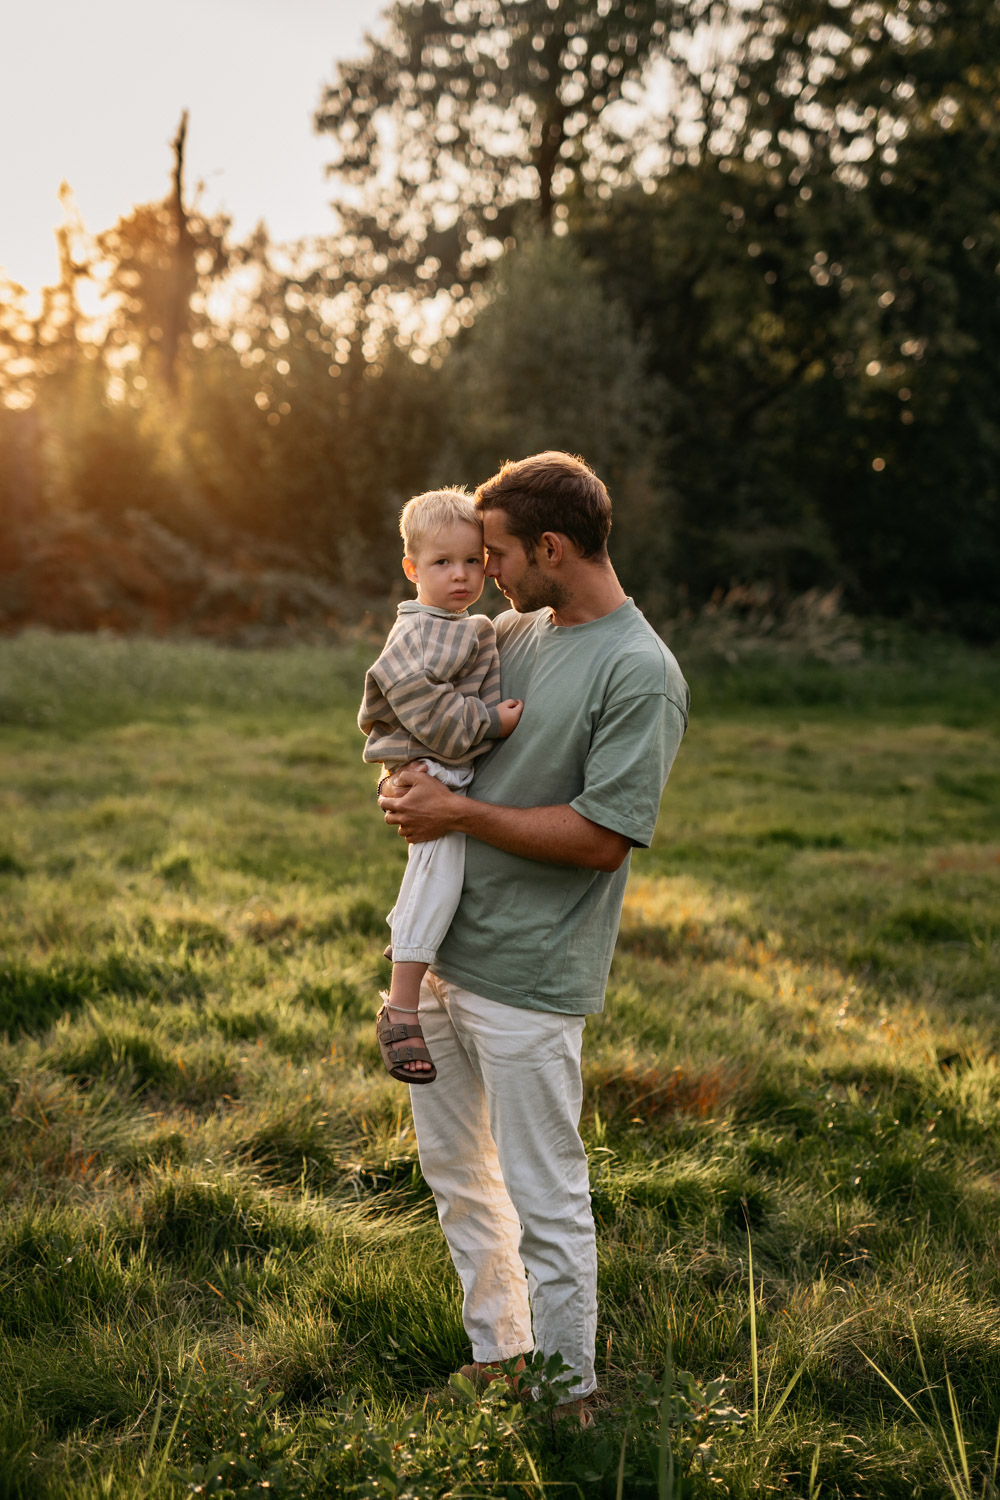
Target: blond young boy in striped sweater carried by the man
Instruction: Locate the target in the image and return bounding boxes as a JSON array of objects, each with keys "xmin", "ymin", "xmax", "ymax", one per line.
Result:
[{"xmin": 358, "ymin": 489, "xmax": 523, "ymax": 1083}]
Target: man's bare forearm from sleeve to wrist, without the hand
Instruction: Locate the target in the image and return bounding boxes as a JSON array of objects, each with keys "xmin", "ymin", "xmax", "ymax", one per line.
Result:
[{"xmin": 454, "ymin": 798, "xmax": 631, "ymax": 872}]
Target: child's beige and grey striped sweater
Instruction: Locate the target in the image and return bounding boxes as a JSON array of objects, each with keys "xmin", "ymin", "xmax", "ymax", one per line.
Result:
[{"xmin": 358, "ymin": 599, "xmax": 501, "ymax": 768}]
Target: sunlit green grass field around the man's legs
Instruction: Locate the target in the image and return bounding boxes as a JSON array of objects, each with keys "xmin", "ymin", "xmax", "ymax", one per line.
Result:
[{"xmin": 0, "ymin": 635, "xmax": 1000, "ymax": 1500}]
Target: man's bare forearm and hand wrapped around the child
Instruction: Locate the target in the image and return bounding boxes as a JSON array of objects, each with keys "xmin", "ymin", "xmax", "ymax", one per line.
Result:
[{"xmin": 378, "ymin": 767, "xmax": 631, "ymax": 873}]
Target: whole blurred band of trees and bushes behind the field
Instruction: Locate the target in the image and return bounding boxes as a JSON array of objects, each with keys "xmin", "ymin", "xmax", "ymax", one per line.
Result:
[{"xmin": 0, "ymin": 0, "xmax": 1000, "ymax": 639}]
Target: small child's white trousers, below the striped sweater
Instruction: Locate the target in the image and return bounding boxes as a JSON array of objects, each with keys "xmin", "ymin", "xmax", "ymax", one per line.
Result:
[{"xmin": 385, "ymin": 761, "xmax": 472, "ymax": 963}]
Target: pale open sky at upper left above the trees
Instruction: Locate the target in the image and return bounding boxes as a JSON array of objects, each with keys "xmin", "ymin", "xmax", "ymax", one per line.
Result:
[{"xmin": 0, "ymin": 0, "xmax": 385, "ymax": 301}]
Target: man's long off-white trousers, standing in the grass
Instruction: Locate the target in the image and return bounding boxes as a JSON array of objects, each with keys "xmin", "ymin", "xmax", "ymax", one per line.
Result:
[{"xmin": 409, "ymin": 974, "xmax": 597, "ymax": 1397}]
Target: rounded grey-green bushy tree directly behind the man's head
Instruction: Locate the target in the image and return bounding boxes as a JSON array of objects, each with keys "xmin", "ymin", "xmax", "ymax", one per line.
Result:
[{"xmin": 435, "ymin": 236, "xmax": 673, "ymax": 617}]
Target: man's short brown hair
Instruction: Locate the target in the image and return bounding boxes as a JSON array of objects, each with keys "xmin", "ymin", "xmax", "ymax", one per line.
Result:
[{"xmin": 475, "ymin": 449, "xmax": 612, "ymax": 558}]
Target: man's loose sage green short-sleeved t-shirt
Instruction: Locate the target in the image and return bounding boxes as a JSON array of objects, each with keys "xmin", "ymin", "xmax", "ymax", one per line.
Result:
[{"xmin": 433, "ymin": 599, "xmax": 688, "ymax": 1016}]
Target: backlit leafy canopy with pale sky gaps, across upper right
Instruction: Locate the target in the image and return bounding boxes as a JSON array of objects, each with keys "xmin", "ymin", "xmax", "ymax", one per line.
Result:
[{"xmin": 316, "ymin": 0, "xmax": 1000, "ymax": 294}]
